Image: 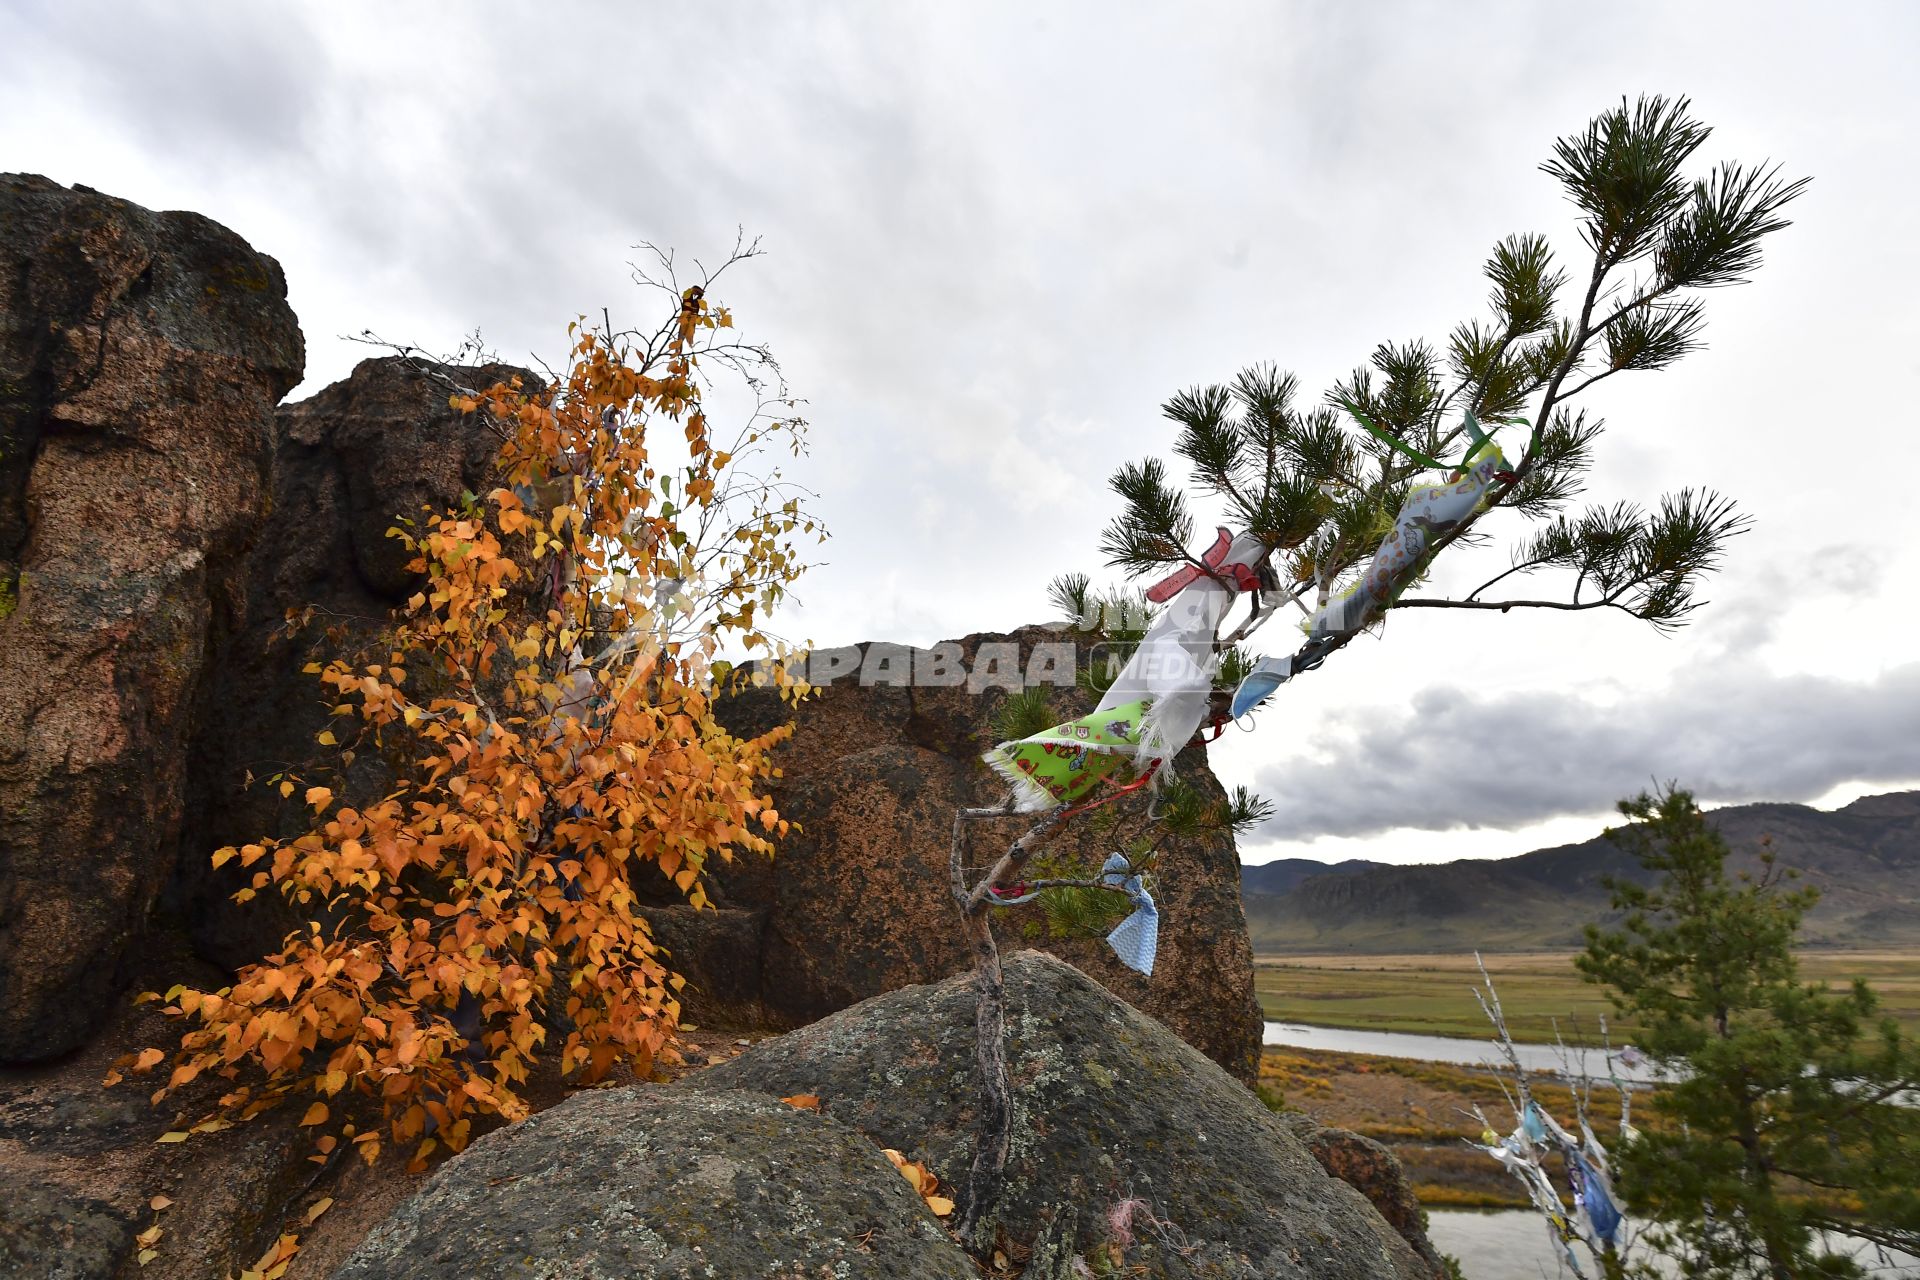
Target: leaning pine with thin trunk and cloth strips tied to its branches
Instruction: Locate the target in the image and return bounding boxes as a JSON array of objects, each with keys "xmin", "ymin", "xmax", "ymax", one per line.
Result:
[{"xmin": 952, "ymin": 96, "xmax": 1807, "ymax": 1242}]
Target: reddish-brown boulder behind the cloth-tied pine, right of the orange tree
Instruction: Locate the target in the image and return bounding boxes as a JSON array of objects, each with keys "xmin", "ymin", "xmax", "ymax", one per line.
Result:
[{"xmin": 702, "ymin": 628, "xmax": 1261, "ymax": 1080}]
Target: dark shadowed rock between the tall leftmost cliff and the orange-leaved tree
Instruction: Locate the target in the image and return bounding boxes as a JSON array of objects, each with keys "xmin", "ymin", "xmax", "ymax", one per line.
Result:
[{"xmin": 167, "ymin": 357, "xmax": 536, "ymax": 969}]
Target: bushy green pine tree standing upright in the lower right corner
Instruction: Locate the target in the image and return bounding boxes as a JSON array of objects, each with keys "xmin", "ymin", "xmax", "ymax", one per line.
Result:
[{"xmin": 1576, "ymin": 787, "xmax": 1920, "ymax": 1280}]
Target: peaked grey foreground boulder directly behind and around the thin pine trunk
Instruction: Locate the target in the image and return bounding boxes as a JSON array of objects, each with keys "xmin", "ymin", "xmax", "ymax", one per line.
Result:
[{"xmin": 695, "ymin": 950, "xmax": 1434, "ymax": 1280}]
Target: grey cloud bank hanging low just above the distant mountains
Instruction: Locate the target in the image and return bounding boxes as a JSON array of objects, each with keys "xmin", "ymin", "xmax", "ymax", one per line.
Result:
[{"xmin": 1256, "ymin": 662, "xmax": 1920, "ymax": 841}]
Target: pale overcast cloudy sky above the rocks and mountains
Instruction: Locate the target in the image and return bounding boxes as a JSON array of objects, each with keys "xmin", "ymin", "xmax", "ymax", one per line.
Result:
[{"xmin": 0, "ymin": 0, "xmax": 1920, "ymax": 862}]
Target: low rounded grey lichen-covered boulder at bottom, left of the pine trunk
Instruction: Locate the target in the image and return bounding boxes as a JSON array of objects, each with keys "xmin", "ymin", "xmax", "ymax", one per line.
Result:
[{"xmin": 334, "ymin": 1086, "xmax": 977, "ymax": 1280}]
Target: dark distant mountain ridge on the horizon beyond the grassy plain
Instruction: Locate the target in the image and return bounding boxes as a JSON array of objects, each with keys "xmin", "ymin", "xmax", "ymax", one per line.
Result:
[{"xmin": 1240, "ymin": 791, "xmax": 1920, "ymax": 954}]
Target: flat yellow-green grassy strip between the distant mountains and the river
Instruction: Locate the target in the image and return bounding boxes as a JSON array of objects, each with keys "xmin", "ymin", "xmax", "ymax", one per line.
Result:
[{"xmin": 1254, "ymin": 950, "xmax": 1920, "ymax": 1042}]
